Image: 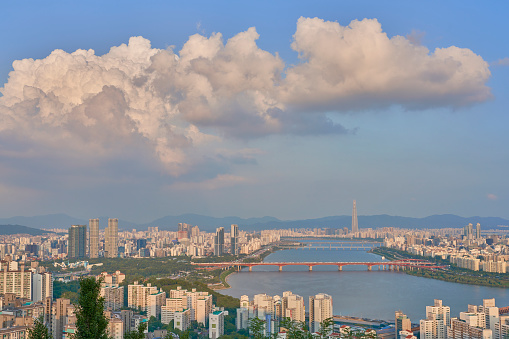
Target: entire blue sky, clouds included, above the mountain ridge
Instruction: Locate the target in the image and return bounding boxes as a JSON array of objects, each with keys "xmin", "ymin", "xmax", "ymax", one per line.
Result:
[{"xmin": 0, "ymin": 1, "xmax": 509, "ymax": 221}]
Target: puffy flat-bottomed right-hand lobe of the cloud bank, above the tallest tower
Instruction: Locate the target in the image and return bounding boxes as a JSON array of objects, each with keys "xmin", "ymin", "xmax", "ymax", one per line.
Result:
[{"xmin": 280, "ymin": 18, "xmax": 491, "ymax": 111}]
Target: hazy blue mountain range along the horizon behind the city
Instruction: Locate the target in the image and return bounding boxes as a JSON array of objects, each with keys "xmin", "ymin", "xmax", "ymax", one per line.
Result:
[{"xmin": 0, "ymin": 214, "xmax": 509, "ymax": 234}]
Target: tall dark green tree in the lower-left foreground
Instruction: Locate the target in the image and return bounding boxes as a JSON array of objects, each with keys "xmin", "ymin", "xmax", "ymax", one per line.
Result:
[{"xmin": 74, "ymin": 277, "xmax": 108, "ymax": 339}]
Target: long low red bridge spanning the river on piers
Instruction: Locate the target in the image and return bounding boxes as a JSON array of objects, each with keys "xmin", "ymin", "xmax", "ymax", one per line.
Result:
[{"xmin": 192, "ymin": 259, "xmax": 447, "ymax": 272}]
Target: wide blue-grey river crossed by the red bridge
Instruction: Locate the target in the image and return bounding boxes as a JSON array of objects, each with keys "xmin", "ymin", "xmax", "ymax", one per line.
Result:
[{"xmin": 221, "ymin": 242, "xmax": 509, "ymax": 323}]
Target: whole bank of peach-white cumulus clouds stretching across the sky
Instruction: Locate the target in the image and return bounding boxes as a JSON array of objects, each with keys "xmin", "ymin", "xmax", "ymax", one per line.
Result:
[{"xmin": 0, "ymin": 18, "xmax": 491, "ymax": 187}]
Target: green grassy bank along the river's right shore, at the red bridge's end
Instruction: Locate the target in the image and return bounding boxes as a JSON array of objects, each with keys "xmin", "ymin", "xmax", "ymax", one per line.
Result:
[{"xmin": 371, "ymin": 247, "xmax": 509, "ymax": 288}]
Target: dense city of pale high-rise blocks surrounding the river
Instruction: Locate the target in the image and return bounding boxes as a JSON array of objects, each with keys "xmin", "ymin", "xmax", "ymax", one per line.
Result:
[{"xmin": 0, "ymin": 201, "xmax": 509, "ymax": 339}]
